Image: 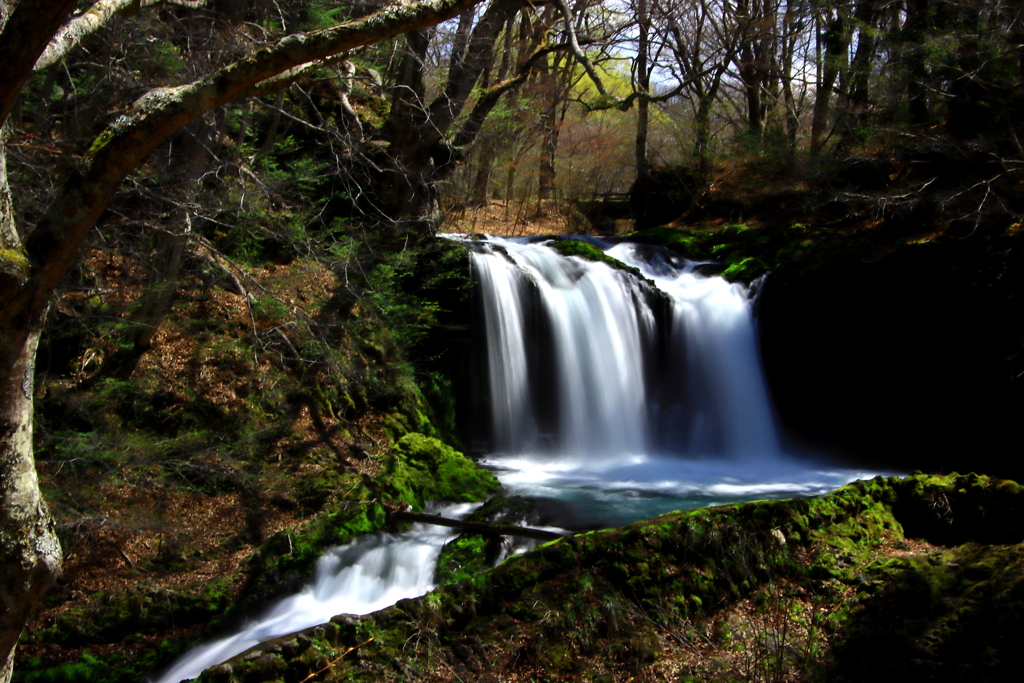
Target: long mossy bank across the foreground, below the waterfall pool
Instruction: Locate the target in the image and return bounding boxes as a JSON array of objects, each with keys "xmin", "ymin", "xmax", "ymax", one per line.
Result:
[{"xmin": 195, "ymin": 474, "xmax": 1024, "ymax": 683}]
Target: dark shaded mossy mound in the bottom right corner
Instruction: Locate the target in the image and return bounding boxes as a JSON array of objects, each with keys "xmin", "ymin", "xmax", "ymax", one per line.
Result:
[{"xmin": 825, "ymin": 544, "xmax": 1024, "ymax": 681}]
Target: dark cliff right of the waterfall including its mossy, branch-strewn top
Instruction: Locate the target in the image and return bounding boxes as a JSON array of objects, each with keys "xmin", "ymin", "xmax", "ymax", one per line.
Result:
[{"xmin": 633, "ymin": 141, "xmax": 1024, "ymax": 478}]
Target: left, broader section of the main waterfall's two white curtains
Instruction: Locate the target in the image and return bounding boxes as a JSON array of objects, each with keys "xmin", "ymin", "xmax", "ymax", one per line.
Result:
[{"xmin": 473, "ymin": 241, "xmax": 650, "ymax": 456}]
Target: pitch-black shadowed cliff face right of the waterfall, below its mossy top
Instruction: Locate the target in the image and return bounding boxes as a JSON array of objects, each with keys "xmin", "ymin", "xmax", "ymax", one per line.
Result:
[{"xmin": 760, "ymin": 233, "xmax": 1024, "ymax": 478}]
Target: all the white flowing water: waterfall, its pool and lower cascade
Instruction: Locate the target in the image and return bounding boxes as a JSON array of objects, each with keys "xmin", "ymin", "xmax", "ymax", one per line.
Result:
[{"xmin": 156, "ymin": 233, "xmax": 873, "ymax": 683}]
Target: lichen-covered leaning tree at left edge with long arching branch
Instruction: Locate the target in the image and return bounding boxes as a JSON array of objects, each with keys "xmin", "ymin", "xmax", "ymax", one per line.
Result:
[{"xmin": 0, "ymin": 0, "xmax": 500, "ymax": 683}]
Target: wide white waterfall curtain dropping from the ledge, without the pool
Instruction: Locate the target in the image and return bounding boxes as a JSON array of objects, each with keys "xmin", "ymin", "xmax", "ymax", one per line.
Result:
[{"xmin": 472, "ymin": 238, "xmax": 779, "ymax": 462}]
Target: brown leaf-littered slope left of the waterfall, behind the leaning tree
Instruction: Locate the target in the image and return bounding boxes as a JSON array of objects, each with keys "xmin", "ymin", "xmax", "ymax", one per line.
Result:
[{"xmin": 17, "ymin": 250, "xmax": 411, "ymax": 680}]
